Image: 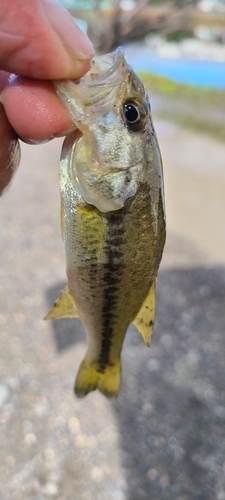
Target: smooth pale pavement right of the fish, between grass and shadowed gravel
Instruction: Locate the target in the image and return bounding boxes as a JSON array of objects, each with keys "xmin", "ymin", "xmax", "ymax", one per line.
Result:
[{"xmin": 159, "ymin": 122, "xmax": 225, "ymax": 264}]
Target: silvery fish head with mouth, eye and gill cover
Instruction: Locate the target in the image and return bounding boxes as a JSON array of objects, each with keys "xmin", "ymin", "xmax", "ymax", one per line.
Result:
[{"xmin": 55, "ymin": 47, "xmax": 162, "ymax": 216}]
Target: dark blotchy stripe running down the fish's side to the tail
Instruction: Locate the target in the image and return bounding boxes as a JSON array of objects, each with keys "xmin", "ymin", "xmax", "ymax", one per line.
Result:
[{"xmin": 98, "ymin": 214, "xmax": 124, "ymax": 372}]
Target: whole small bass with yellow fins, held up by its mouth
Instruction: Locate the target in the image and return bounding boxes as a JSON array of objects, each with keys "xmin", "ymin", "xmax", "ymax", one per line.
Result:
[{"xmin": 46, "ymin": 47, "xmax": 166, "ymax": 400}]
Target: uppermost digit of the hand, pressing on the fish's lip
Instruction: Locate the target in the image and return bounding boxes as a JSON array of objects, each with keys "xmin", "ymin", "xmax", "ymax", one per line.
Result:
[{"xmin": 0, "ymin": 0, "xmax": 94, "ymax": 80}]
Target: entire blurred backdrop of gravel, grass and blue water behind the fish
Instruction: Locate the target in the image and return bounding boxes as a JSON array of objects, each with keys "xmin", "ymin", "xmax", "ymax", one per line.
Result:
[{"xmin": 0, "ymin": 0, "xmax": 225, "ymax": 500}]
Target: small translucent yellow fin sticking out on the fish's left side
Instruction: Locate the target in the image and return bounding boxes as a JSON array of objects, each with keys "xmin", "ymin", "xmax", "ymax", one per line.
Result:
[{"xmin": 44, "ymin": 285, "xmax": 78, "ymax": 319}]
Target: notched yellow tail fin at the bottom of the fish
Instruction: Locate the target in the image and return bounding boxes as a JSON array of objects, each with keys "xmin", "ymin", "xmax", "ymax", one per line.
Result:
[{"xmin": 75, "ymin": 357, "xmax": 121, "ymax": 399}]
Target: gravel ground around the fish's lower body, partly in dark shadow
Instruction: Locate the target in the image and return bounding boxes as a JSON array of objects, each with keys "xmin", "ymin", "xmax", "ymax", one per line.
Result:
[{"xmin": 0, "ymin": 127, "xmax": 225, "ymax": 500}]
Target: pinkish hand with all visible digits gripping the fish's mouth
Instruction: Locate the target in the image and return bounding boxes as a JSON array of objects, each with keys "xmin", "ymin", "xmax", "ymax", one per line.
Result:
[{"xmin": 0, "ymin": 0, "xmax": 94, "ymax": 194}]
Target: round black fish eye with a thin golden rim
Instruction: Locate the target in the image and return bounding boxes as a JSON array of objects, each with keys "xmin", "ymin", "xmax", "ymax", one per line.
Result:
[{"xmin": 123, "ymin": 99, "xmax": 146, "ymax": 132}]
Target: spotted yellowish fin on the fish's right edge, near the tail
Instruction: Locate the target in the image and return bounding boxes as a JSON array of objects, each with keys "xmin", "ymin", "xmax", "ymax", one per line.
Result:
[{"xmin": 133, "ymin": 283, "xmax": 155, "ymax": 347}]
